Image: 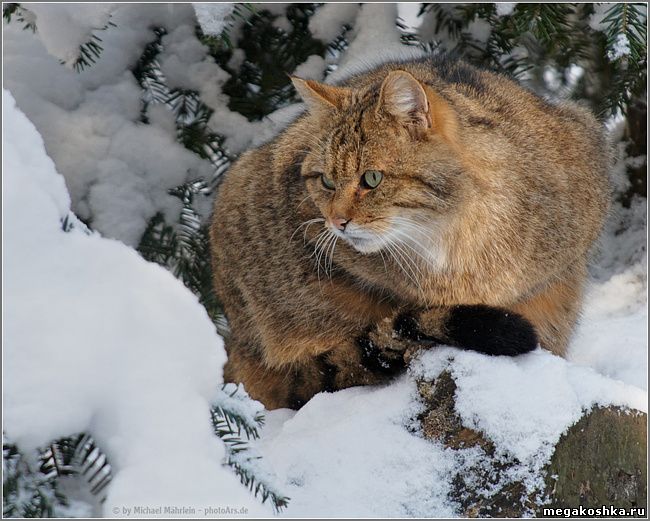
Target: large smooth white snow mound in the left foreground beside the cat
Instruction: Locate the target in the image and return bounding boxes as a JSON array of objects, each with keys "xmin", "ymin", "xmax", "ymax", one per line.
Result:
[{"xmin": 2, "ymin": 90, "xmax": 269, "ymax": 516}]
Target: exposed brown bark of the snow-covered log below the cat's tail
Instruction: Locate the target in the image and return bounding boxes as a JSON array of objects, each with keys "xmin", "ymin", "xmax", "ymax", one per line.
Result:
[{"xmin": 418, "ymin": 372, "xmax": 647, "ymax": 517}]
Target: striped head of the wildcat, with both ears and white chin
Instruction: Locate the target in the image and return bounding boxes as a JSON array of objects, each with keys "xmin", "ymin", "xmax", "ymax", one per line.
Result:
[{"xmin": 293, "ymin": 70, "xmax": 463, "ymax": 260}]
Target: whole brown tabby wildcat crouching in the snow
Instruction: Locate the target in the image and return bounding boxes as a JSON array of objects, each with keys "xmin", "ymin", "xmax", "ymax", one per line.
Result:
[{"xmin": 211, "ymin": 57, "xmax": 610, "ymax": 408}]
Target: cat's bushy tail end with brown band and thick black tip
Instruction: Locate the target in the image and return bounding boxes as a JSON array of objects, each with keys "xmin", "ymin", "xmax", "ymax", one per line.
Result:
[{"xmin": 393, "ymin": 305, "xmax": 538, "ymax": 356}]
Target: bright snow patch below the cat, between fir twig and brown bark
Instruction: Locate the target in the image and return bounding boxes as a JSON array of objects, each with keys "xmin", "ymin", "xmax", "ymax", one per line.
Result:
[{"xmin": 253, "ymin": 378, "xmax": 455, "ymax": 517}]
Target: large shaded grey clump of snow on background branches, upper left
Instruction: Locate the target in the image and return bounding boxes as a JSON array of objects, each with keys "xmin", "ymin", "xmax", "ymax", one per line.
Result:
[{"xmin": 3, "ymin": 4, "xmax": 214, "ymax": 246}]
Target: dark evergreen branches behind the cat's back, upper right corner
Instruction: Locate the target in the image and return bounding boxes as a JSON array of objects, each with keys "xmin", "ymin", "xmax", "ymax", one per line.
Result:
[{"xmin": 421, "ymin": 3, "xmax": 647, "ymax": 117}]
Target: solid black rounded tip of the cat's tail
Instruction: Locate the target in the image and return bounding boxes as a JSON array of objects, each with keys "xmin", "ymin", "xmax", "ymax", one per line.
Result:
[{"xmin": 445, "ymin": 305, "xmax": 537, "ymax": 356}]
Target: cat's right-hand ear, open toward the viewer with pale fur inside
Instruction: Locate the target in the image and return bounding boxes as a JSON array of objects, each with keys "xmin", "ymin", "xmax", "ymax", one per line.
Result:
[{"xmin": 379, "ymin": 71, "xmax": 431, "ymax": 129}]
